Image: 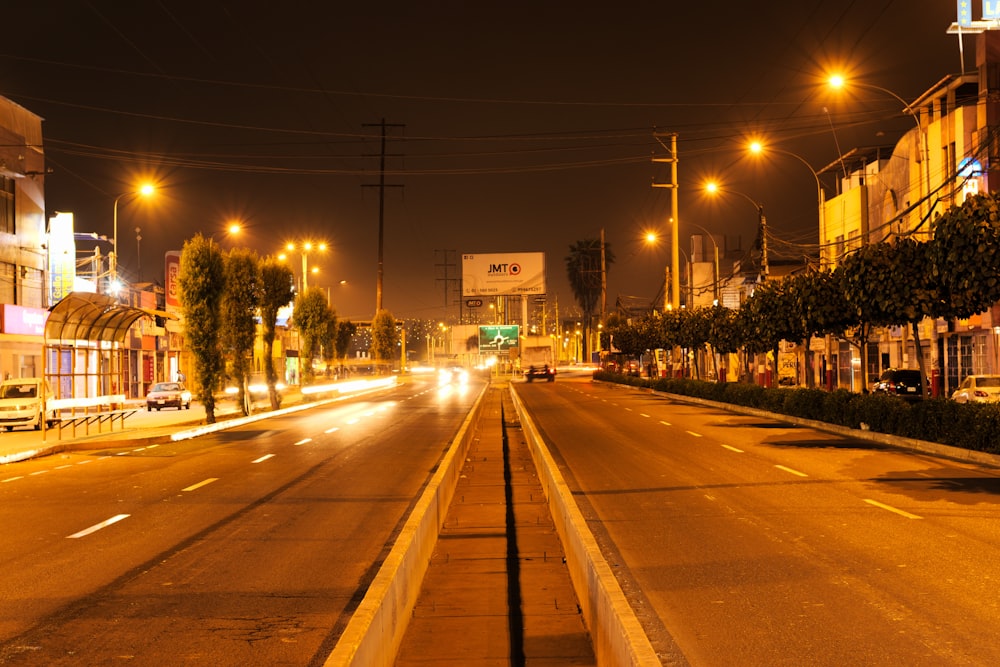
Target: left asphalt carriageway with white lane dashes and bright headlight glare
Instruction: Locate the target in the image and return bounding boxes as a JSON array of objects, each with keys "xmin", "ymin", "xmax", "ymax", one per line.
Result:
[{"xmin": 0, "ymin": 378, "xmax": 482, "ymax": 665}]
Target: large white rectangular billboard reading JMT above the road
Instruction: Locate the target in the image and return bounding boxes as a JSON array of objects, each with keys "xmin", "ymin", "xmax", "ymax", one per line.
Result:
[{"xmin": 462, "ymin": 252, "xmax": 545, "ymax": 297}]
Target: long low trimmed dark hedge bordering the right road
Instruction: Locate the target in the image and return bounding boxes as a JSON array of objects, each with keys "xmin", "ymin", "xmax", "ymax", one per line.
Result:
[{"xmin": 594, "ymin": 371, "xmax": 1000, "ymax": 454}]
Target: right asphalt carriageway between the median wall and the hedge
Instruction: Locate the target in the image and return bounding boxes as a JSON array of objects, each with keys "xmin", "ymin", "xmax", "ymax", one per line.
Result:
[{"xmin": 516, "ymin": 378, "xmax": 1000, "ymax": 666}]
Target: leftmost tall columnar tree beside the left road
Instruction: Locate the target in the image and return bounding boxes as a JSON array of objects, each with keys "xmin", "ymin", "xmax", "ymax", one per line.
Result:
[{"xmin": 177, "ymin": 233, "xmax": 225, "ymax": 424}]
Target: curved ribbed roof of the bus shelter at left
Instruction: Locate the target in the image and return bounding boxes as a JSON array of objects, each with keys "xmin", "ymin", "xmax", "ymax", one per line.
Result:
[{"xmin": 45, "ymin": 292, "xmax": 172, "ymax": 344}]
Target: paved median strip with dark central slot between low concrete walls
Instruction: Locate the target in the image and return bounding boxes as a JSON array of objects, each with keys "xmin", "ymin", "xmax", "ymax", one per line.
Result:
[{"xmin": 395, "ymin": 383, "xmax": 596, "ymax": 667}]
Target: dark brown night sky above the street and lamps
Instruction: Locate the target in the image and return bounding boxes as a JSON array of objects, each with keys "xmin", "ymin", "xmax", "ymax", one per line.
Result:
[{"xmin": 0, "ymin": 0, "xmax": 964, "ymax": 320}]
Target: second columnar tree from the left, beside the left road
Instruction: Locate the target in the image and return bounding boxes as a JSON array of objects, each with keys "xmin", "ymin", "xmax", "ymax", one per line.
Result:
[{"xmin": 221, "ymin": 248, "xmax": 263, "ymax": 416}]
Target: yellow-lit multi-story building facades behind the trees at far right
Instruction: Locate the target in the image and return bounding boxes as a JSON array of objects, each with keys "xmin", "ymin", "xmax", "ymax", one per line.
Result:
[{"xmin": 818, "ymin": 30, "xmax": 1000, "ymax": 395}]
